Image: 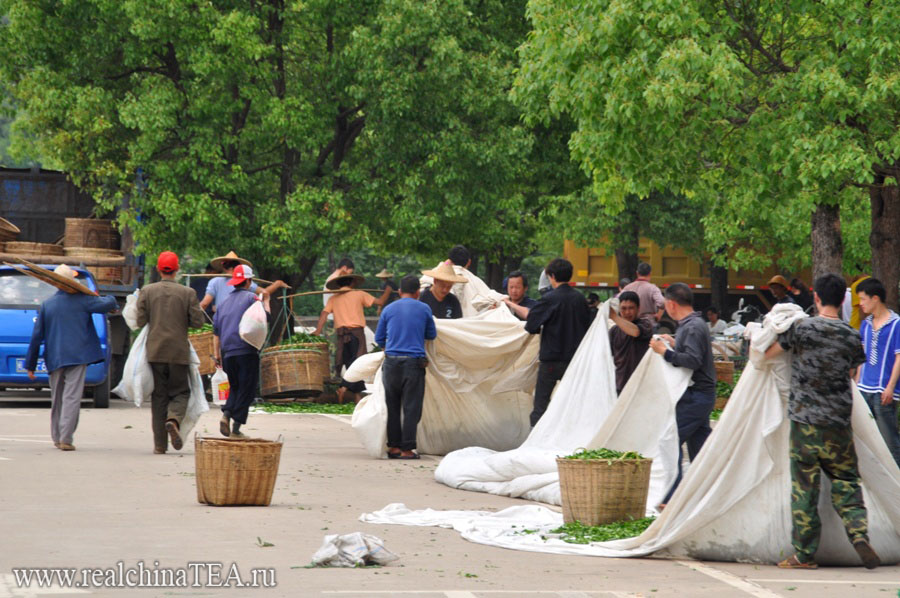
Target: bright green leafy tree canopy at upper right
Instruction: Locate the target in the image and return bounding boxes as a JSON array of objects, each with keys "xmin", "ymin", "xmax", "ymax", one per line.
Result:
[{"xmin": 514, "ymin": 0, "xmax": 900, "ymax": 296}]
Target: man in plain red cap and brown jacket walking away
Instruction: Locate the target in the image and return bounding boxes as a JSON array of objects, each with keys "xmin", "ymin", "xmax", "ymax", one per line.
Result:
[{"xmin": 137, "ymin": 251, "xmax": 203, "ymax": 455}]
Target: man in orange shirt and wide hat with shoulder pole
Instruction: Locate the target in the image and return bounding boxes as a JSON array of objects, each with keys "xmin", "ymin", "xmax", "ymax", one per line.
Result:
[{"xmin": 313, "ymin": 274, "xmax": 391, "ymax": 403}]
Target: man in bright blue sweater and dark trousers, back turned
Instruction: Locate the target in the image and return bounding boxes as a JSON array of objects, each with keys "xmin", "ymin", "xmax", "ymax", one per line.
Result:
[{"xmin": 375, "ymin": 275, "xmax": 437, "ymax": 459}]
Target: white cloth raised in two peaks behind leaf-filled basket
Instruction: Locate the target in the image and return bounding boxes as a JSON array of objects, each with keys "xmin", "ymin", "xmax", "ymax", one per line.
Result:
[{"xmin": 435, "ymin": 302, "xmax": 691, "ymax": 512}]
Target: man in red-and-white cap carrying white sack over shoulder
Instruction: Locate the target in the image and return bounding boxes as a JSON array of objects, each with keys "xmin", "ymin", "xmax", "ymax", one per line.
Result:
[{"xmin": 213, "ymin": 264, "xmax": 259, "ymax": 438}]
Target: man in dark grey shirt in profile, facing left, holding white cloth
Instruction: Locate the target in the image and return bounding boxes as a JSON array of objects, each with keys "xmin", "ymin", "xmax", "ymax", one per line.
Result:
[{"xmin": 650, "ymin": 282, "xmax": 716, "ymax": 506}]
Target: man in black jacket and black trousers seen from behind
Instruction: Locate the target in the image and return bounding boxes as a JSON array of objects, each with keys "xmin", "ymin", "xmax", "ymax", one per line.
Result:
[{"xmin": 525, "ymin": 258, "xmax": 591, "ymax": 426}]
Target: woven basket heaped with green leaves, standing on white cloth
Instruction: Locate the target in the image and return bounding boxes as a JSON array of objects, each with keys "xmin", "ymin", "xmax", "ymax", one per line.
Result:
[{"xmin": 556, "ymin": 459, "xmax": 653, "ymax": 525}]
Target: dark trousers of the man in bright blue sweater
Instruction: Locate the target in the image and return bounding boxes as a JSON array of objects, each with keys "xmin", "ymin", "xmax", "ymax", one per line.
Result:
[{"xmin": 381, "ymin": 356, "xmax": 425, "ymax": 451}]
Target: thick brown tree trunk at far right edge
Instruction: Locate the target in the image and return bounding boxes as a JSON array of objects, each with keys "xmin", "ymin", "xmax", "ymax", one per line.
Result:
[{"xmin": 869, "ymin": 183, "xmax": 900, "ymax": 311}]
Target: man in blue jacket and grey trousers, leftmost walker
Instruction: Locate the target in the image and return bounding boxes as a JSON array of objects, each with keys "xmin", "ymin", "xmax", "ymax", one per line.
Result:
[{"xmin": 25, "ymin": 264, "xmax": 116, "ymax": 451}]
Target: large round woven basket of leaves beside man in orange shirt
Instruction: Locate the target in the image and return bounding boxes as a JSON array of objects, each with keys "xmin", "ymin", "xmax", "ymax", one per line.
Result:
[{"xmin": 260, "ymin": 343, "xmax": 328, "ymax": 398}]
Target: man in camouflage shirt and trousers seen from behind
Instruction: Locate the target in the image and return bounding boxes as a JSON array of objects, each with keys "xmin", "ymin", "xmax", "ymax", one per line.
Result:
[{"xmin": 766, "ymin": 274, "xmax": 881, "ymax": 569}]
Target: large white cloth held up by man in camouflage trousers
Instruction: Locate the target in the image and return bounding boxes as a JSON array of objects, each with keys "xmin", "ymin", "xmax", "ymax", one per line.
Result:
[{"xmin": 361, "ymin": 304, "xmax": 900, "ymax": 566}]
